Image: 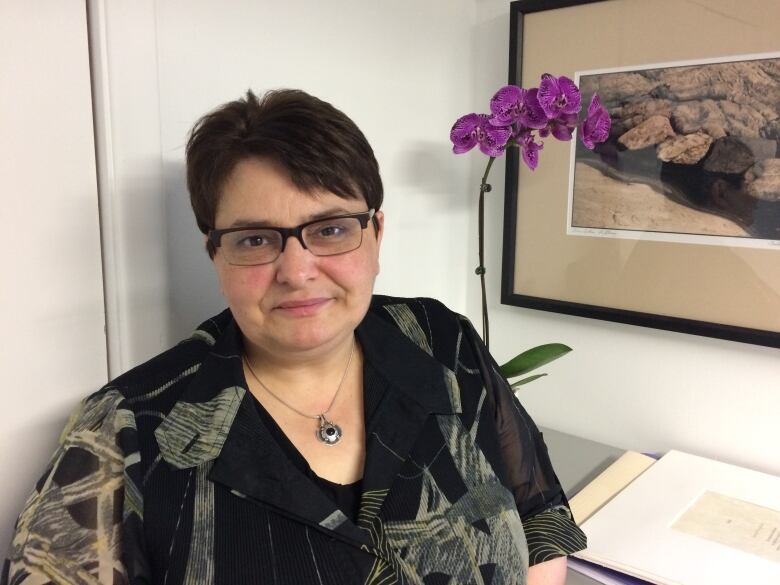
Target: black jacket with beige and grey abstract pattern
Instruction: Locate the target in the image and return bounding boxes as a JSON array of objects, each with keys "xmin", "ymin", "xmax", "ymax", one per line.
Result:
[{"xmin": 0, "ymin": 296, "xmax": 585, "ymax": 585}]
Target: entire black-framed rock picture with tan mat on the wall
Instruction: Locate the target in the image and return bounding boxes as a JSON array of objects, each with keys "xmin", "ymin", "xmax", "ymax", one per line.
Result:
[{"xmin": 501, "ymin": 0, "xmax": 780, "ymax": 347}]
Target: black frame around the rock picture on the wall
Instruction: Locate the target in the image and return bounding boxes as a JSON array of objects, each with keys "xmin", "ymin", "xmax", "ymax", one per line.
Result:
[{"xmin": 501, "ymin": 0, "xmax": 780, "ymax": 348}]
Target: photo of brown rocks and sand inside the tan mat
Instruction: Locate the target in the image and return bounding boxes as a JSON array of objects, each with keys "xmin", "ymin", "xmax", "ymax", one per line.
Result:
[{"xmin": 570, "ymin": 58, "xmax": 780, "ymax": 243}]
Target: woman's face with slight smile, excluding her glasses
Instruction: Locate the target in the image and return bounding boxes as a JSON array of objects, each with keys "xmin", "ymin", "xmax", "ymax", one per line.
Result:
[{"xmin": 214, "ymin": 159, "xmax": 384, "ymax": 358}]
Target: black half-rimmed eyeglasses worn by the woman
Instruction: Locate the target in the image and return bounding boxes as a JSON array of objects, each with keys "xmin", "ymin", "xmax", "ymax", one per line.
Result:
[{"xmin": 208, "ymin": 209, "xmax": 376, "ymax": 266}]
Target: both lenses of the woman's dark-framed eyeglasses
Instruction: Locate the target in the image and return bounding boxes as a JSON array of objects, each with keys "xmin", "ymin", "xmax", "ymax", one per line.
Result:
[{"xmin": 222, "ymin": 217, "xmax": 363, "ymax": 266}]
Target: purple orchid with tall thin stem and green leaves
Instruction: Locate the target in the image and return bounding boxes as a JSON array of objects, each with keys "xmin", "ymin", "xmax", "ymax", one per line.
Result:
[{"xmin": 450, "ymin": 73, "xmax": 611, "ymax": 389}]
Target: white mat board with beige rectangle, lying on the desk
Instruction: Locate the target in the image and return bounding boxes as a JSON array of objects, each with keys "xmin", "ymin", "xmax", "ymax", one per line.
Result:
[{"xmin": 577, "ymin": 451, "xmax": 780, "ymax": 585}]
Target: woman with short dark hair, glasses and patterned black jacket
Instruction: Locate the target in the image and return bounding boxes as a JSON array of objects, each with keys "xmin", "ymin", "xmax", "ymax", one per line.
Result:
[{"xmin": 1, "ymin": 91, "xmax": 584, "ymax": 585}]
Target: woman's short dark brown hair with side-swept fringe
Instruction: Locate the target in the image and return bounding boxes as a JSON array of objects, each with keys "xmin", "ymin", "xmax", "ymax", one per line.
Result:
[{"xmin": 186, "ymin": 89, "xmax": 383, "ymax": 249}]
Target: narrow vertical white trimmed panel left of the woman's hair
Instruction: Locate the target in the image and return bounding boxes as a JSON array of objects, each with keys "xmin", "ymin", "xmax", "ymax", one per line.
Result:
[{"xmin": 88, "ymin": 0, "xmax": 171, "ymax": 377}]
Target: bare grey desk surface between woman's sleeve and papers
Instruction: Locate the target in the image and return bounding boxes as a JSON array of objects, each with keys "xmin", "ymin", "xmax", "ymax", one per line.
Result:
[{"xmin": 540, "ymin": 428, "xmax": 625, "ymax": 585}]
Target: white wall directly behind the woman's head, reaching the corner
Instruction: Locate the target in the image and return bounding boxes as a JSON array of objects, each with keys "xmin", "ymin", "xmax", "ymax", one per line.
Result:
[{"xmin": 99, "ymin": 0, "xmax": 482, "ymax": 364}]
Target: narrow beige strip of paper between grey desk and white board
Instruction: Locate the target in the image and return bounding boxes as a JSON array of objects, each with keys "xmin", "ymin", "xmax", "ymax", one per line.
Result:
[{"xmin": 569, "ymin": 451, "xmax": 655, "ymax": 523}]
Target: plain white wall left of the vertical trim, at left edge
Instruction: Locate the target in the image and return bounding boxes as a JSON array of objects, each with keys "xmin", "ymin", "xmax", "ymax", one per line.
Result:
[{"xmin": 0, "ymin": 0, "xmax": 107, "ymax": 550}]
